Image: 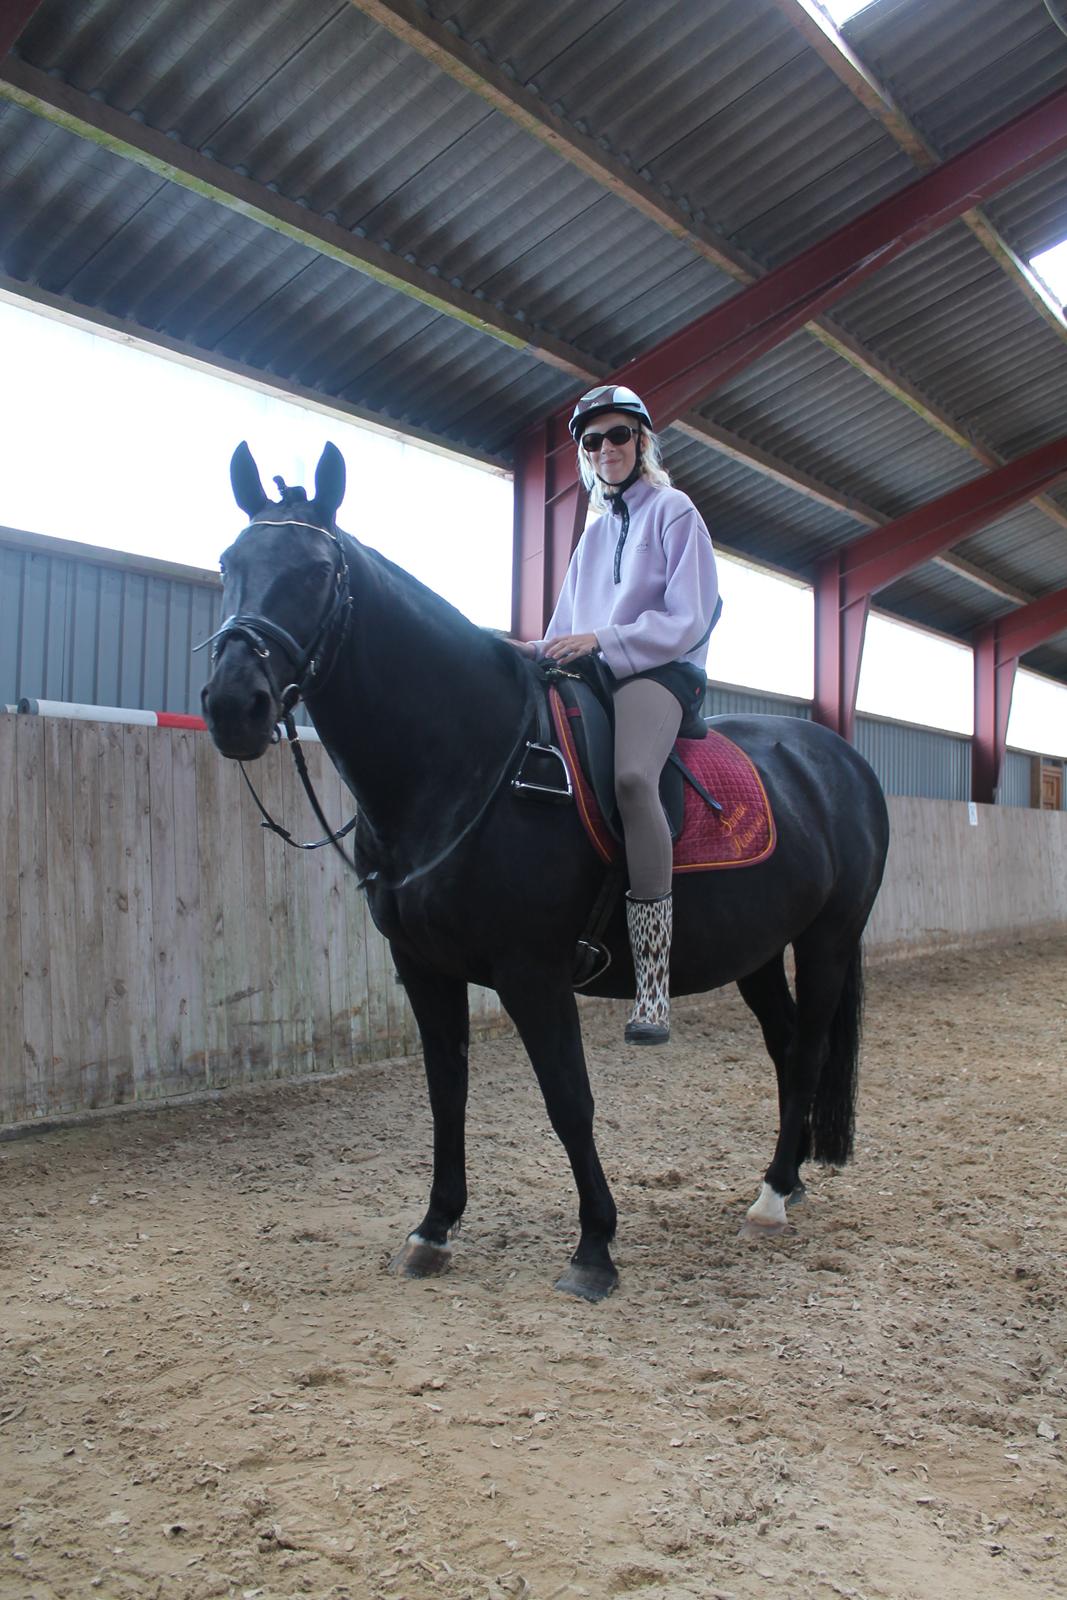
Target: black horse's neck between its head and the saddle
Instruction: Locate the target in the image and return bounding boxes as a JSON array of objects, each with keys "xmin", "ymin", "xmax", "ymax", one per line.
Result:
[{"xmin": 309, "ymin": 546, "xmax": 525, "ymax": 854}]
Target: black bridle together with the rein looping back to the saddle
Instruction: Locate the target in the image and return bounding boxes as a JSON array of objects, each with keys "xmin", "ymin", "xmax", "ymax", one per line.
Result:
[{"xmin": 194, "ymin": 517, "xmax": 536, "ymax": 891}]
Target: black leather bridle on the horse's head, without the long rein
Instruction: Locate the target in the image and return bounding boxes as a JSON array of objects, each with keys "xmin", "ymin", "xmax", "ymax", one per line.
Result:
[{"xmin": 194, "ymin": 517, "xmax": 358, "ymax": 872}]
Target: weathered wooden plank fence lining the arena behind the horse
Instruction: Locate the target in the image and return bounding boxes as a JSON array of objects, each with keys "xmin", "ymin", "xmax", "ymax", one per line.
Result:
[{"xmin": 0, "ymin": 714, "xmax": 1067, "ymax": 1123}]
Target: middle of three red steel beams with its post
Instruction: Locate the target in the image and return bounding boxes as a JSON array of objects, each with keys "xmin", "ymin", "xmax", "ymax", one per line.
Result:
[{"xmin": 814, "ymin": 437, "xmax": 1067, "ymax": 739}]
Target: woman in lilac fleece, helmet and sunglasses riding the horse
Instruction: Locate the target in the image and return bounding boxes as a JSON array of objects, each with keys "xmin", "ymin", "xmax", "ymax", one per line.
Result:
[{"xmin": 518, "ymin": 384, "xmax": 720, "ymax": 1045}]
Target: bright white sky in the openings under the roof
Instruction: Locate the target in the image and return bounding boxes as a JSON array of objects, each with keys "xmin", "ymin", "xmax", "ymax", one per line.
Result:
[{"xmin": 0, "ymin": 294, "xmax": 1067, "ymax": 757}]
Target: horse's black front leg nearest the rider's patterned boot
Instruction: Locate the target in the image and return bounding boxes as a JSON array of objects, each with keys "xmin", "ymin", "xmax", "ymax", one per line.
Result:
[{"xmin": 496, "ymin": 968, "xmax": 619, "ymax": 1301}]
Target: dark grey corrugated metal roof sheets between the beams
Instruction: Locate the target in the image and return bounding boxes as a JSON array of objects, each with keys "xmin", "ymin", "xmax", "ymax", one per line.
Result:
[{"xmin": 0, "ymin": 0, "xmax": 1067, "ymax": 677}]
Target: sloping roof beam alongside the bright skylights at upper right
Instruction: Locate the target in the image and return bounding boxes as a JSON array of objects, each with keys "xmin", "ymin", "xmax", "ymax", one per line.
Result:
[{"xmin": 774, "ymin": 0, "xmax": 1067, "ymax": 339}]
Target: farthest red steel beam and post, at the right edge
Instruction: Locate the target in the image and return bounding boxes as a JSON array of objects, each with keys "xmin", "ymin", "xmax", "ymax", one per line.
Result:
[{"xmin": 971, "ymin": 589, "xmax": 1067, "ymax": 805}]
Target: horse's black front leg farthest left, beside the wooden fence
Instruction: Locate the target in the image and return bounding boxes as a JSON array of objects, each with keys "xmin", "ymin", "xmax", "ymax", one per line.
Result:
[{"xmin": 390, "ymin": 949, "xmax": 470, "ymax": 1278}]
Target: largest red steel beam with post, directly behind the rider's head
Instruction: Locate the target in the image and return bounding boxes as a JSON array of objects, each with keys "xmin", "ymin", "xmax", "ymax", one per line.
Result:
[{"xmin": 515, "ymin": 90, "xmax": 1067, "ymax": 619}]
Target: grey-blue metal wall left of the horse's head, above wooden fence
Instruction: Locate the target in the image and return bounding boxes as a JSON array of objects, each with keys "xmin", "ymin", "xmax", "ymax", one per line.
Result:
[{"xmin": 0, "ymin": 528, "xmax": 221, "ymax": 712}]
